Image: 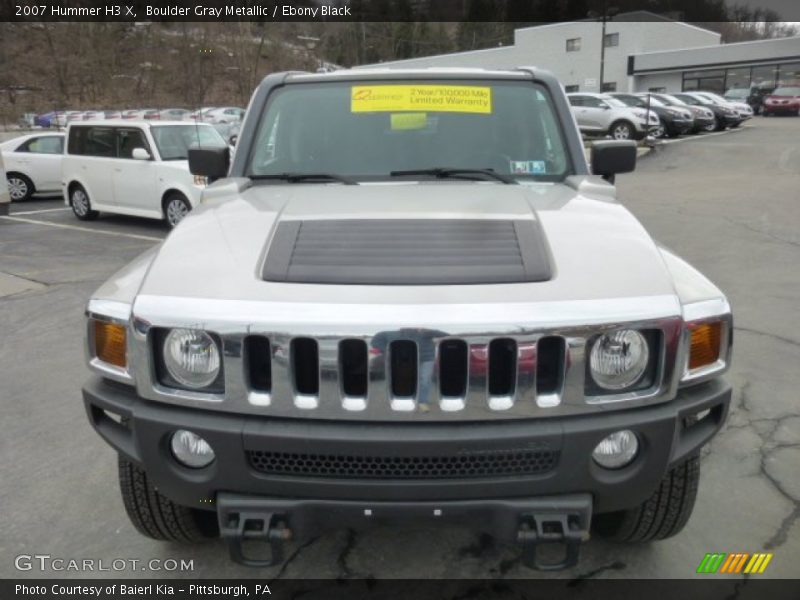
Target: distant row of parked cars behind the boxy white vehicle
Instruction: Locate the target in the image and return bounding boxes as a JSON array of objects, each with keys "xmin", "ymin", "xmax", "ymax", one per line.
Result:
[{"xmin": 23, "ymin": 106, "xmax": 245, "ymax": 128}]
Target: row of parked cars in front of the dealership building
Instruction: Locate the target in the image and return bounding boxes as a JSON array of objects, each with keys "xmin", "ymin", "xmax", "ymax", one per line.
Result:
[{"xmin": 567, "ymin": 92, "xmax": 766, "ymax": 140}]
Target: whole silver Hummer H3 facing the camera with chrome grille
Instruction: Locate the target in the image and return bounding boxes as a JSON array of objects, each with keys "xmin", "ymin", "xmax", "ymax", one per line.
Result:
[{"xmin": 83, "ymin": 68, "xmax": 732, "ymax": 569}]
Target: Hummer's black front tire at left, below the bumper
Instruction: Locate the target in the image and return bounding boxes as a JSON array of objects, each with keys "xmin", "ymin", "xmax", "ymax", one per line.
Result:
[{"xmin": 118, "ymin": 456, "xmax": 219, "ymax": 543}]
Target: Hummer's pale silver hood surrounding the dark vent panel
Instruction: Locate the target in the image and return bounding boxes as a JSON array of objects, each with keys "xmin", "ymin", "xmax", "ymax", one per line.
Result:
[{"xmin": 140, "ymin": 181, "xmax": 675, "ymax": 304}]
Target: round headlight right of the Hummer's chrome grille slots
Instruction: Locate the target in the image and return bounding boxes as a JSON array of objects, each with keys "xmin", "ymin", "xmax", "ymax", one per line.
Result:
[{"xmin": 589, "ymin": 329, "xmax": 650, "ymax": 390}]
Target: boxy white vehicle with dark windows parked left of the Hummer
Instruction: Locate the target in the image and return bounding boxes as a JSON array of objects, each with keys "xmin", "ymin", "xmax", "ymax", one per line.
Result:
[{"xmin": 61, "ymin": 121, "xmax": 227, "ymax": 227}]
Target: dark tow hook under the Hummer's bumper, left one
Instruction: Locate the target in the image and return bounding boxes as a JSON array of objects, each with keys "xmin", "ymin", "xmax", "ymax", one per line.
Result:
[{"xmin": 219, "ymin": 511, "xmax": 292, "ymax": 567}]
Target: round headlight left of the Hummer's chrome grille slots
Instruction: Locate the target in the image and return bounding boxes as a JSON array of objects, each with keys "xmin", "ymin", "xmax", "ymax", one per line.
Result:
[{"xmin": 164, "ymin": 329, "xmax": 220, "ymax": 390}]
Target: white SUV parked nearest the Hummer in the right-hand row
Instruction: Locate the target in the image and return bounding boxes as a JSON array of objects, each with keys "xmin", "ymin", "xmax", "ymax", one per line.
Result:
[{"xmin": 567, "ymin": 92, "xmax": 659, "ymax": 140}]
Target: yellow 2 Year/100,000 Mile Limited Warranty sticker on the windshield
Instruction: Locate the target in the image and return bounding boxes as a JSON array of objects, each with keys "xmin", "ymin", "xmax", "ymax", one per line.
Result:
[{"xmin": 350, "ymin": 85, "xmax": 492, "ymax": 115}]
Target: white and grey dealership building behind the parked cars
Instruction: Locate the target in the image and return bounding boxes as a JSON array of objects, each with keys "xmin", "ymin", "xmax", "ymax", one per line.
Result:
[{"xmin": 364, "ymin": 11, "xmax": 800, "ymax": 93}]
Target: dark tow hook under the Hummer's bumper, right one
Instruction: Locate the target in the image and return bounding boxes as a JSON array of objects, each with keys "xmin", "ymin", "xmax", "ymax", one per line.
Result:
[{"xmin": 517, "ymin": 509, "xmax": 591, "ymax": 571}]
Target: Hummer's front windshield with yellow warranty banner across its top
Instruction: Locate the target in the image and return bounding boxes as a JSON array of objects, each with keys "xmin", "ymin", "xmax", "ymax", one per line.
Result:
[{"xmin": 246, "ymin": 80, "xmax": 570, "ymax": 181}]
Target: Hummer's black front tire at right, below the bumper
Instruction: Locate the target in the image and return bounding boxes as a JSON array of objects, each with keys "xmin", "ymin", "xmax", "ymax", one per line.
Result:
[{"xmin": 594, "ymin": 456, "xmax": 700, "ymax": 542}]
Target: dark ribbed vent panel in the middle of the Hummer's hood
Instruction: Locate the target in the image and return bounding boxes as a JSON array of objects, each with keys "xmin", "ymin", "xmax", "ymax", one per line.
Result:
[{"xmin": 262, "ymin": 219, "xmax": 552, "ymax": 285}]
